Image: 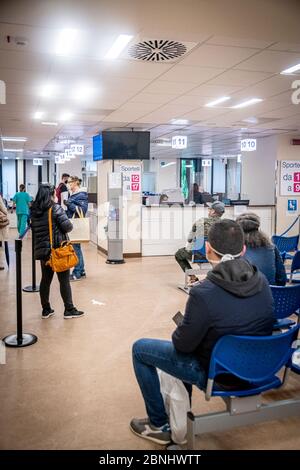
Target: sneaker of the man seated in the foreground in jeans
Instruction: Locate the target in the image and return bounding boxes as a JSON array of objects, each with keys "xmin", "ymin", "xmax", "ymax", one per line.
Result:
[{"xmin": 130, "ymin": 418, "xmax": 171, "ymax": 445}]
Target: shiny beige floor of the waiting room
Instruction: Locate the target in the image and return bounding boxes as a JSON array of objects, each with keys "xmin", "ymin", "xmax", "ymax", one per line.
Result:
[{"xmin": 0, "ymin": 233, "xmax": 300, "ymax": 449}]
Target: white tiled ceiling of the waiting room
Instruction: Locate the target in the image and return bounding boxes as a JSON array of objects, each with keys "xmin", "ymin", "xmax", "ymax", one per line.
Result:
[{"xmin": 0, "ymin": 0, "xmax": 300, "ymax": 158}]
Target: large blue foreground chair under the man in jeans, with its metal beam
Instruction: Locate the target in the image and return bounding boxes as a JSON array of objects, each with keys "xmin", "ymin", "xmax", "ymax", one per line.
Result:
[{"xmin": 187, "ymin": 326, "xmax": 300, "ymax": 449}]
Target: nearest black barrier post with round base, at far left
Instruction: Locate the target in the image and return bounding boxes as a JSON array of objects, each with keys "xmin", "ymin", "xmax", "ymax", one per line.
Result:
[{"xmin": 3, "ymin": 239, "xmax": 37, "ymax": 348}]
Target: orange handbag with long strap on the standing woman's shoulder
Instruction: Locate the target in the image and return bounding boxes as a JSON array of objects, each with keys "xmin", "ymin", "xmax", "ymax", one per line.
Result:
[{"xmin": 46, "ymin": 207, "xmax": 78, "ymax": 273}]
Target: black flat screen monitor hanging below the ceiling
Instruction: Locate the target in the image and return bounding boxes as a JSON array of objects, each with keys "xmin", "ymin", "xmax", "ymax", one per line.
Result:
[{"xmin": 102, "ymin": 131, "xmax": 150, "ymax": 160}]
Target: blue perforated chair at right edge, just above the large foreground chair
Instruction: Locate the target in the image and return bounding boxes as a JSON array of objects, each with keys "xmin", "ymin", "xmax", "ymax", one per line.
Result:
[{"xmin": 270, "ymin": 284, "xmax": 300, "ymax": 330}]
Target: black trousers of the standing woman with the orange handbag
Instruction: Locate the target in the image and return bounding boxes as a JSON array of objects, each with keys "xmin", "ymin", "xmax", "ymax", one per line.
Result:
[{"xmin": 40, "ymin": 260, "xmax": 73, "ymax": 310}]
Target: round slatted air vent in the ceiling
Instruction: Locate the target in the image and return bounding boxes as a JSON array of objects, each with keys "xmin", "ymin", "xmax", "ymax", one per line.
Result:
[{"xmin": 128, "ymin": 39, "xmax": 187, "ymax": 62}]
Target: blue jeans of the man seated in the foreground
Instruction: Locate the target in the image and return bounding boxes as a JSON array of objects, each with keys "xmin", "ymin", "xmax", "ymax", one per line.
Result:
[{"xmin": 132, "ymin": 338, "xmax": 207, "ymax": 427}]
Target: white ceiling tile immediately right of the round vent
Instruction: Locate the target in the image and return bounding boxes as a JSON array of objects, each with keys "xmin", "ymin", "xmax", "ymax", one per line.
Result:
[{"xmin": 180, "ymin": 44, "xmax": 257, "ymax": 68}]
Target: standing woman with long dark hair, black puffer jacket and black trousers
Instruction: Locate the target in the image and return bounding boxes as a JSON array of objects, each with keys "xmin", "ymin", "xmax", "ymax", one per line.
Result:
[{"xmin": 31, "ymin": 184, "xmax": 84, "ymax": 319}]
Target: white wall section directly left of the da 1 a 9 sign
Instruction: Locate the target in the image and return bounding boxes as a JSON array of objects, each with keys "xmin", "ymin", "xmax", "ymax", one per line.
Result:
[{"xmin": 241, "ymin": 136, "xmax": 278, "ymax": 205}]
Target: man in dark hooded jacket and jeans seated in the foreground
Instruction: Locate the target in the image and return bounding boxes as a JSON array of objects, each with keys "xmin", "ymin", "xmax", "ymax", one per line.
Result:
[{"xmin": 130, "ymin": 219, "xmax": 273, "ymax": 444}]
